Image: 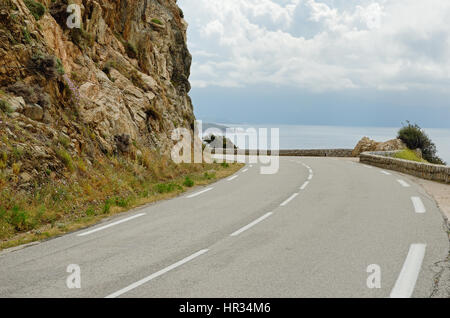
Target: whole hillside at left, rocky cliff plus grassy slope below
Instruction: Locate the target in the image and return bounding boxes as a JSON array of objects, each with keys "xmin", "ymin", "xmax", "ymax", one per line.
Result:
[{"xmin": 0, "ymin": 0, "xmax": 243, "ymax": 247}]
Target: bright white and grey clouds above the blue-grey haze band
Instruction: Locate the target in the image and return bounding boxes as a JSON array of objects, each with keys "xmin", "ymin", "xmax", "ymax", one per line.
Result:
[{"xmin": 179, "ymin": 0, "xmax": 450, "ymax": 91}]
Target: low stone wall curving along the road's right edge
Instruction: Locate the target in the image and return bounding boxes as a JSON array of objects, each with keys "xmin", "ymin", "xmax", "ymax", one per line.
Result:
[{"xmin": 360, "ymin": 151, "xmax": 450, "ymax": 183}]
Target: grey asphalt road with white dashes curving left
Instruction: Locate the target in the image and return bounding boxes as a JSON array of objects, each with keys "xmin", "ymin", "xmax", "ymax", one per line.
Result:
[{"xmin": 0, "ymin": 157, "xmax": 449, "ymax": 297}]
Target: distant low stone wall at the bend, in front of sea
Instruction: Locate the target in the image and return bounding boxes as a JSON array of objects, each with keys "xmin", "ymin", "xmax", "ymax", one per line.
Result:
[{"xmin": 212, "ymin": 149, "xmax": 353, "ymax": 157}]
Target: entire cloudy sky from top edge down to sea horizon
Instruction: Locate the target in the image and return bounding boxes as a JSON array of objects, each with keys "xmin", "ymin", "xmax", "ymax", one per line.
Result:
[{"xmin": 178, "ymin": 0, "xmax": 450, "ymax": 128}]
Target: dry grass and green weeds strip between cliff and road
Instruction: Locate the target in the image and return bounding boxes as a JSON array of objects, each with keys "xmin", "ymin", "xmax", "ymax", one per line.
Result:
[{"xmin": 0, "ymin": 151, "xmax": 242, "ymax": 250}]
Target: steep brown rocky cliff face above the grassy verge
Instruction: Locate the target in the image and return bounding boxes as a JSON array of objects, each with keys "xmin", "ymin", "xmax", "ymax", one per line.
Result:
[{"xmin": 0, "ymin": 0, "xmax": 195, "ymax": 183}]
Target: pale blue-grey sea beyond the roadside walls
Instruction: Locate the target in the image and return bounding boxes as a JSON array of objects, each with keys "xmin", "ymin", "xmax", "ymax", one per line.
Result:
[{"xmin": 204, "ymin": 123, "xmax": 450, "ymax": 165}]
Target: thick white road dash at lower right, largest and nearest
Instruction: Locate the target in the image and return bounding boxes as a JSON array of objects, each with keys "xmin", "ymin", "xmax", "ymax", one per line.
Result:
[{"xmin": 390, "ymin": 244, "xmax": 427, "ymax": 298}]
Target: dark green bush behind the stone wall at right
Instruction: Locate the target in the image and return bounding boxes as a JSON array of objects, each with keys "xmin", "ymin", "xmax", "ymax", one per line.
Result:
[{"xmin": 398, "ymin": 121, "xmax": 445, "ymax": 164}]
